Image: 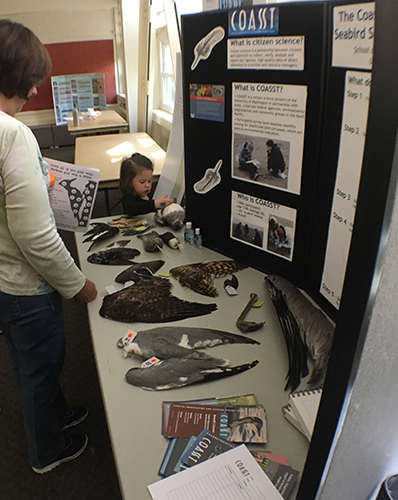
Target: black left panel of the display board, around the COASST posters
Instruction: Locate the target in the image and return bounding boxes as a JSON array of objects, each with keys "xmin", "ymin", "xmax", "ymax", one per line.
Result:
[{"xmin": 182, "ymin": 2, "xmax": 335, "ymax": 312}]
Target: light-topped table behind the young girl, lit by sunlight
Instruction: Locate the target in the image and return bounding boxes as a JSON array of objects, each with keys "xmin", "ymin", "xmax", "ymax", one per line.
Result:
[{"xmin": 75, "ymin": 132, "xmax": 166, "ymax": 214}]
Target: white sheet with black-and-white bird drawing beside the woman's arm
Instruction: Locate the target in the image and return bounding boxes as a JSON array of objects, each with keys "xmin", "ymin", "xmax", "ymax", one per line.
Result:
[{"xmin": 44, "ymin": 158, "xmax": 100, "ymax": 232}]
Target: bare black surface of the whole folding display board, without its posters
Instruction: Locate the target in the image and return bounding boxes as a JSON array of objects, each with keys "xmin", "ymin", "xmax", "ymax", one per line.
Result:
[{"xmin": 182, "ymin": 0, "xmax": 398, "ymax": 500}]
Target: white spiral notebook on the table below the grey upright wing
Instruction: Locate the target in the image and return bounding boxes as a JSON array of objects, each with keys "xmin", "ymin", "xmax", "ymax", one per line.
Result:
[{"xmin": 289, "ymin": 386, "xmax": 322, "ymax": 440}]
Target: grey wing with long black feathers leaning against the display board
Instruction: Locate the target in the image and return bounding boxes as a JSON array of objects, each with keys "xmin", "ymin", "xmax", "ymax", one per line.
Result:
[{"xmin": 265, "ymin": 274, "xmax": 334, "ymax": 391}]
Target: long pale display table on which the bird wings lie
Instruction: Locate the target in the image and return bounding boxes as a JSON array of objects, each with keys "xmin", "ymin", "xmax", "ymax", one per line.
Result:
[{"xmin": 76, "ymin": 214, "xmax": 309, "ymax": 500}]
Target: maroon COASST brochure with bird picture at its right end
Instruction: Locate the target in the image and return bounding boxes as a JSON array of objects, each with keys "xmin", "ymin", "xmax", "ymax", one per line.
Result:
[{"xmin": 162, "ymin": 402, "xmax": 267, "ymax": 443}]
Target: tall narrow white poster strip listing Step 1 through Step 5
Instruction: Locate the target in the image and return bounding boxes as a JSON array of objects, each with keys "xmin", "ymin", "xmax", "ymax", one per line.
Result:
[{"xmin": 320, "ymin": 71, "xmax": 372, "ymax": 309}]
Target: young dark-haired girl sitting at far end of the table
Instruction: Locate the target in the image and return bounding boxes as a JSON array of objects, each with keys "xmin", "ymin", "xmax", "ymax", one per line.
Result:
[{"xmin": 119, "ymin": 153, "xmax": 174, "ymax": 215}]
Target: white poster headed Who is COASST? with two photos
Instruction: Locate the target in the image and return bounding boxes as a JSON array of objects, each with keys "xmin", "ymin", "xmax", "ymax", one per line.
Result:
[{"xmin": 230, "ymin": 191, "xmax": 297, "ymax": 261}]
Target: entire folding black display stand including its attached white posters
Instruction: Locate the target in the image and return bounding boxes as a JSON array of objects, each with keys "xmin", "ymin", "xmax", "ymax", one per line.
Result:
[{"xmin": 182, "ymin": 0, "xmax": 398, "ymax": 500}]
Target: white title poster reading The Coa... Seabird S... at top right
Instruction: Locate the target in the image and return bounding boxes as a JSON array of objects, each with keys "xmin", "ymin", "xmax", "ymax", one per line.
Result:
[{"xmin": 332, "ymin": 2, "xmax": 376, "ymax": 69}]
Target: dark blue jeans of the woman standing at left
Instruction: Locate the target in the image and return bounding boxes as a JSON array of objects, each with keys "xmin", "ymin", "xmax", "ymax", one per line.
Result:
[{"xmin": 0, "ymin": 291, "xmax": 68, "ymax": 468}]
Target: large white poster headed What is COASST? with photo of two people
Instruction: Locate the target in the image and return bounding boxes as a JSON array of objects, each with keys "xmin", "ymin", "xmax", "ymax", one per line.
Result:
[{"xmin": 231, "ymin": 83, "xmax": 307, "ymax": 194}]
